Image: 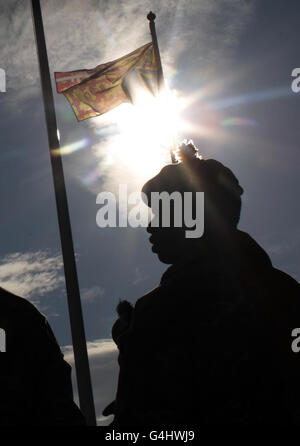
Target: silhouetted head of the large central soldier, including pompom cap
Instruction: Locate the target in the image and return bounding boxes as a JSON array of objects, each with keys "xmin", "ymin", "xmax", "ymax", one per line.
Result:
[{"xmin": 142, "ymin": 142, "xmax": 243, "ymax": 264}]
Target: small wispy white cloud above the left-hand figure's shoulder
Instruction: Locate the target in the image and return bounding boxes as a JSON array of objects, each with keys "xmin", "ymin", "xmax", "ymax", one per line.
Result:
[{"xmin": 0, "ymin": 251, "xmax": 64, "ymax": 300}]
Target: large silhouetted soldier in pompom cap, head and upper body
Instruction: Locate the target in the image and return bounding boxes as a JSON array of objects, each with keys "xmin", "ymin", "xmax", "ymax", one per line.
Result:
[{"xmin": 104, "ymin": 144, "xmax": 300, "ymax": 427}]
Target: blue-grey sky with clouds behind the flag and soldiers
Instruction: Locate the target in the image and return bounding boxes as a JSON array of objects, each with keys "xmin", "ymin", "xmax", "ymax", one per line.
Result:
[{"xmin": 0, "ymin": 0, "xmax": 300, "ymax": 426}]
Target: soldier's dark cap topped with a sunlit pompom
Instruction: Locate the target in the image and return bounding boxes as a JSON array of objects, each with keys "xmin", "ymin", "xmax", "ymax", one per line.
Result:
[{"xmin": 142, "ymin": 143, "xmax": 243, "ymax": 226}]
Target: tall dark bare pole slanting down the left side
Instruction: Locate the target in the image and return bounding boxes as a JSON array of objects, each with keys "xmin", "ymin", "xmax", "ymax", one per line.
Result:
[{"xmin": 31, "ymin": 0, "xmax": 96, "ymax": 426}]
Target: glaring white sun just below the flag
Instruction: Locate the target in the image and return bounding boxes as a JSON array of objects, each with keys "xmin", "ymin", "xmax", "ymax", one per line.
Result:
[{"xmin": 93, "ymin": 89, "xmax": 188, "ymax": 178}]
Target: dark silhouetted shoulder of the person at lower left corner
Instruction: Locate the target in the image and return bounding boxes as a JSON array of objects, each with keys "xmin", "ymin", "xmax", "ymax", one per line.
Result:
[{"xmin": 0, "ymin": 288, "xmax": 85, "ymax": 426}]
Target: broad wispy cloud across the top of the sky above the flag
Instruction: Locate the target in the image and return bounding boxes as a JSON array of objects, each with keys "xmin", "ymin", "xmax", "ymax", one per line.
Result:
[{"xmin": 0, "ymin": 0, "xmax": 253, "ymax": 106}]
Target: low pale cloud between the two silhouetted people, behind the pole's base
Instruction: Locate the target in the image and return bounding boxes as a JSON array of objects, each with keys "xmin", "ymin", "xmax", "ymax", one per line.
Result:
[{"xmin": 62, "ymin": 339, "xmax": 119, "ymax": 426}]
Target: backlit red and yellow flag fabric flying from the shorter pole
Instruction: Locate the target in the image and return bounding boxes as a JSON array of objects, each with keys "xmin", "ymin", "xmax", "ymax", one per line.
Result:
[{"xmin": 55, "ymin": 42, "xmax": 158, "ymax": 121}]
